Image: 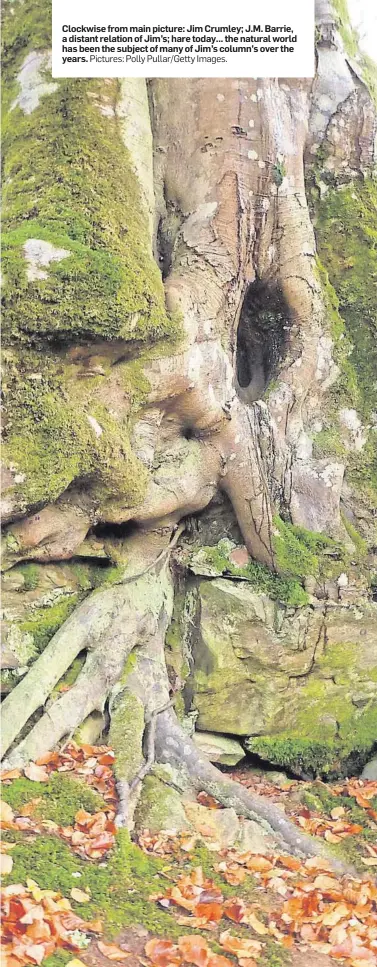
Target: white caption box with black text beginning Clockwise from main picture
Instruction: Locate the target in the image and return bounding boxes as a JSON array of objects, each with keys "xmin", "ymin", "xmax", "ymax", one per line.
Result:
[{"xmin": 52, "ymin": 0, "xmax": 314, "ymax": 78}]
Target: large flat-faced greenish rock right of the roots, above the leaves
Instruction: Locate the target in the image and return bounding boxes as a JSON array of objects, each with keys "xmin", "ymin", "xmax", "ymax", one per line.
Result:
[{"xmin": 188, "ymin": 578, "xmax": 377, "ymax": 775}]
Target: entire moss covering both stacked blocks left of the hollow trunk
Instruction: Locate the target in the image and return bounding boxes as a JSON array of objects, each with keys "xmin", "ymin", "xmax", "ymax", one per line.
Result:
[{"xmin": 3, "ymin": 0, "xmax": 182, "ymax": 506}]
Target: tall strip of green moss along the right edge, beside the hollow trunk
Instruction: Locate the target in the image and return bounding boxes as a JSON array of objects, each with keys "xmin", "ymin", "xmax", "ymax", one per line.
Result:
[{"xmin": 314, "ymin": 183, "xmax": 377, "ymax": 508}]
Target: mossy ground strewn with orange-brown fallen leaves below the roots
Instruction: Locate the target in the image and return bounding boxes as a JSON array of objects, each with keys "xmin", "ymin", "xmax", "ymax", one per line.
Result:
[{"xmin": 1, "ymin": 743, "xmax": 377, "ymax": 967}]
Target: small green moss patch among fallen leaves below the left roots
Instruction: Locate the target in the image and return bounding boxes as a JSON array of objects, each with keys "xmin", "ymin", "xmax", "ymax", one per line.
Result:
[{"xmin": 2, "ymin": 772, "xmax": 105, "ymax": 826}]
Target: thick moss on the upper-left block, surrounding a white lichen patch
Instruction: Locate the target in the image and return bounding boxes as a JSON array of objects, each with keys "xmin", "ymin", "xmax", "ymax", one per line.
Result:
[{"xmin": 3, "ymin": 0, "xmax": 176, "ymax": 342}]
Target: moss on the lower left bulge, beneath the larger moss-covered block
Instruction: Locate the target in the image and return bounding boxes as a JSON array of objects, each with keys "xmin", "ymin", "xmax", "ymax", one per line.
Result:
[{"xmin": 3, "ymin": 360, "xmax": 148, "ymax": 506}]
